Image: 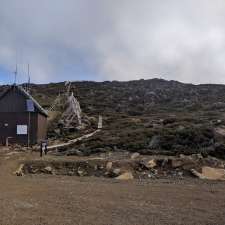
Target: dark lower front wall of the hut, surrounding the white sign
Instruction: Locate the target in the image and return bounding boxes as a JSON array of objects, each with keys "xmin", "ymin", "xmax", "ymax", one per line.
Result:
[{"xmin": 0, "ymin": 112, "xmax": 38, "ymax": 145}]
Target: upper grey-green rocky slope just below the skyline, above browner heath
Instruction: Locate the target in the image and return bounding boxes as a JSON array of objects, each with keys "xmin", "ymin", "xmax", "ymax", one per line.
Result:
[{"xmin": 29, "ymin": 79, "xmax": 225, "ymax": 116}]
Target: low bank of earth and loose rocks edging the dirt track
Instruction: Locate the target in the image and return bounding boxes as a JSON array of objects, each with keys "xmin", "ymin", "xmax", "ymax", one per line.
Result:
[{"xmin": 20, "ymin": 151, "xmax": 225, "ymax": 181}]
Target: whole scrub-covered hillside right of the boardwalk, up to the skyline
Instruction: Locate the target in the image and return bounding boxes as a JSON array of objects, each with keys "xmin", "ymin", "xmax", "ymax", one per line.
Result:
[{"xmin": 1, "ymin": 79, "xmax": 225, "ymax": 157}]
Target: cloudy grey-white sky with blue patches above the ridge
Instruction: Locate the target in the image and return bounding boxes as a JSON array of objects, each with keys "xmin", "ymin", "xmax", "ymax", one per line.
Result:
[{"xmin": 0, "ymin": 0, "xmax": 225, "ymax": 83}]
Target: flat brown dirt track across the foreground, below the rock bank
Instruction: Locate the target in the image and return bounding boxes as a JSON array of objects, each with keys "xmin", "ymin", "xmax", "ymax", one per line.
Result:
[{"xmin": 0, "ymin": 151, "xmax": 225, "ymax": 225}]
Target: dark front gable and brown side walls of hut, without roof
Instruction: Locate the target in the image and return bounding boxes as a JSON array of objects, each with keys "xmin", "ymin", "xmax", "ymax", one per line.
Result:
[{"xmin": 0, "ymin": 87, "xmax": 47, "ymax": 145}]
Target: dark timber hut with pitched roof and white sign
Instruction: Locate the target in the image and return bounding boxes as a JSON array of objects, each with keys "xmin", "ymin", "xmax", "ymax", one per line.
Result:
[{"xmin": 0, "ymin": 85, "xmax": 48, "ymax": 146}]
